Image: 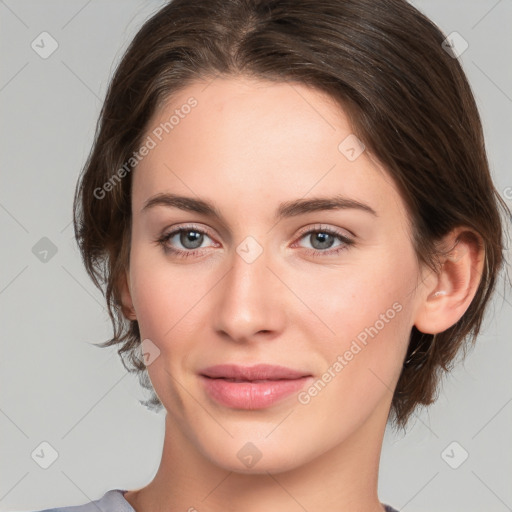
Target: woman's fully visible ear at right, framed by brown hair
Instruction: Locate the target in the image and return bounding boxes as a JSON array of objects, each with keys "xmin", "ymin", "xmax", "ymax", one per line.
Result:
[{"xmin": 414, "ymin": 227, "xmax": 485, "ymax": 334}]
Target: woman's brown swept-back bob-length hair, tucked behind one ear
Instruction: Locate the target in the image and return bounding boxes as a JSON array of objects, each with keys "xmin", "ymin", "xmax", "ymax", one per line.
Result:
[{"xmin": 74, "ymin": 0, "xmax": 510, "ymax": 427}]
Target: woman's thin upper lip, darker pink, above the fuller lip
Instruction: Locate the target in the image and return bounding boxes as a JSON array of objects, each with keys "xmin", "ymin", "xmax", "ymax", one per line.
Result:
[{"xmin": 199, "ymin": 364, "xmax": 311, "ymax": 381}]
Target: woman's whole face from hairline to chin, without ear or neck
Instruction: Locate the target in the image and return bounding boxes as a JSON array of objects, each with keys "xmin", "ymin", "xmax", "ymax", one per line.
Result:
[{"xmin": 123, "ymin": 78, "xmax": 428, "ymax": 472}]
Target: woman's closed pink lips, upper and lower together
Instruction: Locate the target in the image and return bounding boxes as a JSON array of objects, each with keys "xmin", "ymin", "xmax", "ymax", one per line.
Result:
[{"xmin": 199, "ymin": 364, "xmax": 312, "ymax": 410}]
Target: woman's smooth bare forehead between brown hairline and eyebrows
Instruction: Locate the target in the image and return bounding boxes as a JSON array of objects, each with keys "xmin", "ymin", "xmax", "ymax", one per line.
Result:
[{"xmin": 133, "ymin": 78, "xmax": 405, "ymax": 226}]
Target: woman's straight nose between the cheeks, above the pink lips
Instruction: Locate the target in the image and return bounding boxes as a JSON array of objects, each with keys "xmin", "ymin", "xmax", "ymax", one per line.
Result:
[{"xmin": 213, "ymin": 240, "xmax": 291, "ymax": 343}]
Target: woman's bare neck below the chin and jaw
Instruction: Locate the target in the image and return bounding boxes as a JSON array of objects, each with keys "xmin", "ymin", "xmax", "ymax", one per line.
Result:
[{"xmin": 125, "ymin": 404, "xmax": 387, "ymax": 512}]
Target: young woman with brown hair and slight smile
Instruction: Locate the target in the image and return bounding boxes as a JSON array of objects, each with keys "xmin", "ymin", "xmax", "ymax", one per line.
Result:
[{"xmin": 33, "ymin": 0, "xmax": 506, "ymax": 512}]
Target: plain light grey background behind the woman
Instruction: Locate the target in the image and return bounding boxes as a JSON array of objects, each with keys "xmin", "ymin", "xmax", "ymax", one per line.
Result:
[{"xmin": 0, "ymin": 0, "xmax": 512, "ymax": 512}]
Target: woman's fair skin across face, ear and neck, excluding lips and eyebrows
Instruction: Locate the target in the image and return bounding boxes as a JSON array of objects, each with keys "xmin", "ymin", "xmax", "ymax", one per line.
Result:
[{"xmin": 120, "ymin": 77, "xmax": 483, "ymax": 512}]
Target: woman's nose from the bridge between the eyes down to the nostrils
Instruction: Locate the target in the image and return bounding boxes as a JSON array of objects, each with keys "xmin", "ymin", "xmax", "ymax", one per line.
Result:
[{"xmin": 215, "ymin": 236, "xmax": 283, "ymax": 340}]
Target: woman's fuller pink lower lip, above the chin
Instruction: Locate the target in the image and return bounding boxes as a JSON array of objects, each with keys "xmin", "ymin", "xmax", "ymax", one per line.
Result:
[{"xmin": 200, "ymin": 375, "xmax": 312, "ymax": 409}]
